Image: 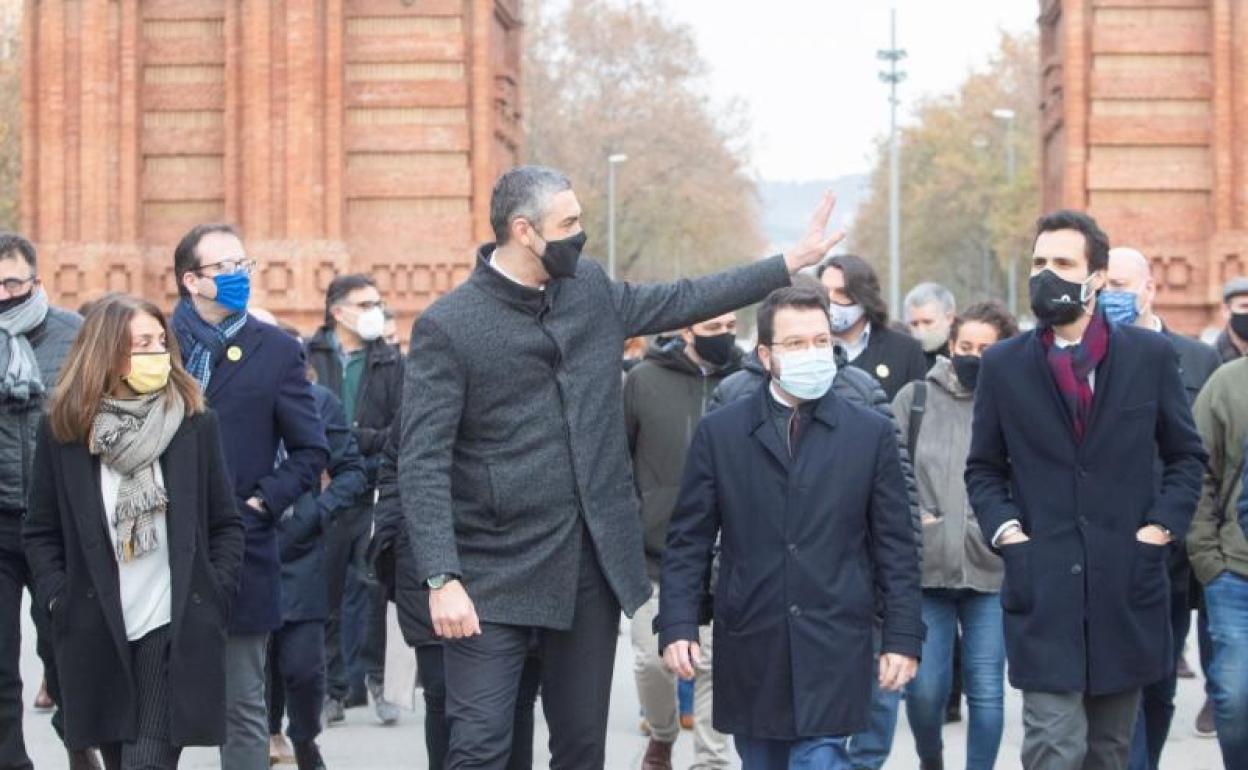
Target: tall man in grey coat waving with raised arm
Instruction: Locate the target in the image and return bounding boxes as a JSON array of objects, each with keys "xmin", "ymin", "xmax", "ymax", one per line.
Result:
[{"xmin": 398, "ymin": 166, "xmax": 842, "ymax": 770}]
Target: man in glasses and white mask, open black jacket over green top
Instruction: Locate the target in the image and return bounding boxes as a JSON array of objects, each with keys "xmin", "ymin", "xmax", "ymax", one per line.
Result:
[{"xmin": 307, "ymin": 273, "xmax": 403, "ymax": 725}]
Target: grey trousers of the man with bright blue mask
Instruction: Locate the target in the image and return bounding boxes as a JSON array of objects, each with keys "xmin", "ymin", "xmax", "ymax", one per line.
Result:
[{"xmin": 221, "ymin": 634, "xmax": 268, "ymax": 770}]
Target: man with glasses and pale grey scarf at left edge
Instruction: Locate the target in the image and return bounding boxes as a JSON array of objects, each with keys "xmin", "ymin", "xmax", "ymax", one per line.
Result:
[{"xmin": 0, "ymin": 232, "xmax": 91, "ymax": 770}]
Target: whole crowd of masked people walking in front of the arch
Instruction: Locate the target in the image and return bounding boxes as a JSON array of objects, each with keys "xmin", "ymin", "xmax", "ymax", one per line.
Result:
[{"xmin": 0, "ymin": 166, "xmax": 1248, "ymax": 770}]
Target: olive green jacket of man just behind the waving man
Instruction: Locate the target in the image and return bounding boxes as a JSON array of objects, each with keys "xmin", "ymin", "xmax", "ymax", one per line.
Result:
[{"xmin": 624, "ymin": 337, "xmax": 740, "ymax": 582}]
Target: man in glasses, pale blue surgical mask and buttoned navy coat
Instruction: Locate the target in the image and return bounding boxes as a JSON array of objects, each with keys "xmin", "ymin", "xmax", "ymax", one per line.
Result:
[{"xmin": 655, "ymin": 287, "xmax": 924, "ymax": 770}]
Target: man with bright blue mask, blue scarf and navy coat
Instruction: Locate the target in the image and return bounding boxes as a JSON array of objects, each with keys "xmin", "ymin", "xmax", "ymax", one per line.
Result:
[{"xmin": 173, "ymin": 225, "xmax": 329, "ymax": 770}]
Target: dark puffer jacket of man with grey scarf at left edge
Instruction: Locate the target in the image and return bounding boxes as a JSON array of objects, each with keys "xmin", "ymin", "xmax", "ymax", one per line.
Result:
[{"xmin": 0, "ymin": 307, "xmax": 82, "ymax": 515}]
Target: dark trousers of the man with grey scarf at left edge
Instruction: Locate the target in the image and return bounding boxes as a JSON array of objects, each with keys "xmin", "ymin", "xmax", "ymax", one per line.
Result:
[{"xmin": 0, "ymin": 510, "xmax": 61, "ymax": 770}]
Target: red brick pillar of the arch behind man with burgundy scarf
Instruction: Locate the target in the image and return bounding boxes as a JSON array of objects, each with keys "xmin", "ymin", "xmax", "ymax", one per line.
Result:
[{"xmin": 1040, "ymin": 0, "xmax": 1248, "ymax": 332}]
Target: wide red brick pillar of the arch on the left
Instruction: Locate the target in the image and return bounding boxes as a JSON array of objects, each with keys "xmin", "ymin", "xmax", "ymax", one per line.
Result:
[{"xmin": 21, "ymin": 0, "xmax": 520, "ymax": 336}]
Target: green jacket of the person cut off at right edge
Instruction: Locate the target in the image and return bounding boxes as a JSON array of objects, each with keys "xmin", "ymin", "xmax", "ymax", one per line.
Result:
[{"xmin": 1187, "ymin": 358, "xmax": 1248, "ymax": 584}]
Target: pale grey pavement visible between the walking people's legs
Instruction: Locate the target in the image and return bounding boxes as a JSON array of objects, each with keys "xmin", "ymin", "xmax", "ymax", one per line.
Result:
[{"xmin": 22, "ymin": 594, "xmax": 1222, "ymax": 770}]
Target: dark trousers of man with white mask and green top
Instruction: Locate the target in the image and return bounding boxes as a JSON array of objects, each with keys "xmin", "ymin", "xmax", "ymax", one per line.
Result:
[{"xmin": 324, "ymin": 505, "xmax": 372, "ymax": 700}]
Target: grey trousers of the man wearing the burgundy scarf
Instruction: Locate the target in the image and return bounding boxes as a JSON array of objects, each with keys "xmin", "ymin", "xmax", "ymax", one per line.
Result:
[{"xmin": 1022, "ymin": 690, "xmax": 1139, "ymax": 770}]
